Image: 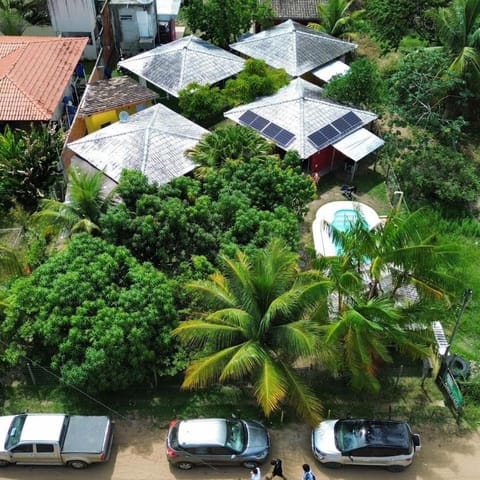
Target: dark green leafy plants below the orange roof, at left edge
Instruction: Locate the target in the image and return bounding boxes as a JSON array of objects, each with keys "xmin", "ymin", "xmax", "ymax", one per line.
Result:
[{"xmin": 0, "ymin": 125, "xmax": 64, "ymax": 211}]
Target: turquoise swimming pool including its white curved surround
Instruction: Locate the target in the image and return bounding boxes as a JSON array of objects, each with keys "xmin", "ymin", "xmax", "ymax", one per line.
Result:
[{"xmin": 312, "ymin": 201, "xmax": 380, "ymax": 257}]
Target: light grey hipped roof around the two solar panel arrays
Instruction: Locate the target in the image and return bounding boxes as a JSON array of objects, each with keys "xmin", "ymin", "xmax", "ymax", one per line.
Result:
[{"xmin": 225, "ymin": 78, "xmax": 377, "ymax": 158}]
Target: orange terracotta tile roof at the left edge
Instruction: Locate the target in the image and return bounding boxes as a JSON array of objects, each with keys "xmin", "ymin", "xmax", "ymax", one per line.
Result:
[{"xmin": 0, "ymin": 36, "xmax": 88, "ymax": 122}]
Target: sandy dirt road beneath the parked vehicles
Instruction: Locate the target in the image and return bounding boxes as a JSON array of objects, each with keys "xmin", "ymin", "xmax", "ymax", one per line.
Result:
[{"xmin": 0, "ymin": 421, "xmax": 480, "ymax": 480}]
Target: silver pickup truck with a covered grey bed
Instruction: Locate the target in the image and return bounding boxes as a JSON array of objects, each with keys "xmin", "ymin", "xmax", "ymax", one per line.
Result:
[{"xmin": 0, "ymin": 413, "xmax": 113, "ymax": 469}]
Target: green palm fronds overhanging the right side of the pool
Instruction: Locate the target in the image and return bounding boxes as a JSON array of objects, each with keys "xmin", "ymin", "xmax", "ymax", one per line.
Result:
[{"xmin": 333, "ymin": 209, "xmax": 460, "ymax": 301}]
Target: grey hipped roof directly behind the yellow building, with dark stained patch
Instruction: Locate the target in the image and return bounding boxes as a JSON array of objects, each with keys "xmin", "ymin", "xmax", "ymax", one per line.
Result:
[{"xmin": 118, "ymin": 35, "xmax": 245, "ymax": 97}]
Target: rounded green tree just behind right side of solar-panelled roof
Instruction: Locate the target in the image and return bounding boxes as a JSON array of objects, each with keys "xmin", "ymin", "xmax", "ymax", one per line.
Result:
[{"xmin": 324, "ymin": 58, "xmax": 386, "ymax": 108}]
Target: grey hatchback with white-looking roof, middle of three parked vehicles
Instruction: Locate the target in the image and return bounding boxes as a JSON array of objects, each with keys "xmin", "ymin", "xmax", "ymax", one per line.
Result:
[{"xmin": 167, "ymin": 418, "xmax": 270, "ymax": 470}]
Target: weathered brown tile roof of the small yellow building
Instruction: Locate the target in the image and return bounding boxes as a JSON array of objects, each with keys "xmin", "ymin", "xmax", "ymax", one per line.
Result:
[{"xmin": 78, "ymin": 76, "xmax": 158, "ymax": 117}]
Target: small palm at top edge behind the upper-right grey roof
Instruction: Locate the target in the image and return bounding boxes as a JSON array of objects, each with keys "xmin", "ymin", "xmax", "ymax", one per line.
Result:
[{"xmin": 309, "ymin": 0, "xmax": 364, "ymax": 37}]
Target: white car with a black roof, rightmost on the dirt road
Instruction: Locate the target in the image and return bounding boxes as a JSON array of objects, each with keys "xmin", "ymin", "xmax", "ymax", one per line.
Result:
[{"xmin": 312, "ymin": 418, "xmax": 421, "ymax": 472}]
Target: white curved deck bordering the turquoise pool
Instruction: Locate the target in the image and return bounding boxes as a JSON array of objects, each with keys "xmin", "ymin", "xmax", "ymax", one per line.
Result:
[{"xmin": 312, "ymin": 201, "xmax": 381, "ymax": 257}]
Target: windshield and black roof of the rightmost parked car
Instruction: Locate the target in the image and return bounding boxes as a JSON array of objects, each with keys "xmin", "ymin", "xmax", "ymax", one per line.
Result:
[{"xmin": 335, "ymin": 420, "xmax": 410, "ymax": 452}]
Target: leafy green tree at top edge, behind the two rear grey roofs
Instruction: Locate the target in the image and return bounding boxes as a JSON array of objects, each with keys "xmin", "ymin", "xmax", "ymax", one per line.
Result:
[{"xmin": 183, "ymin": 0, "xmax": 273, "ymax": 48}]
